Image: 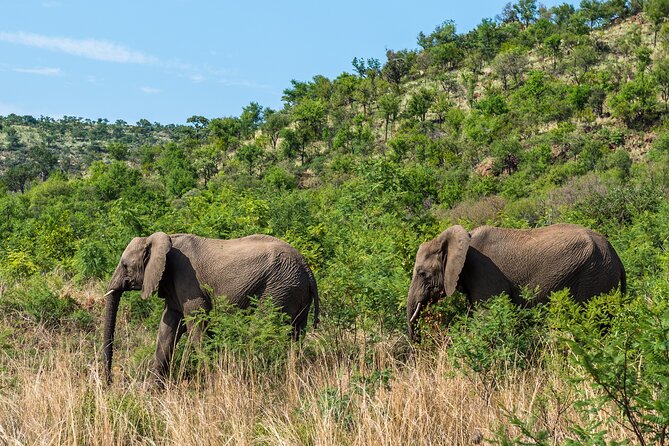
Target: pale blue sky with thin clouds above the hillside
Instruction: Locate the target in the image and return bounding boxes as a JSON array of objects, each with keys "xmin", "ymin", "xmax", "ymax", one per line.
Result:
[{"xmin": 0, "ymin": 0, "xmax": 577, "ymax": 124}]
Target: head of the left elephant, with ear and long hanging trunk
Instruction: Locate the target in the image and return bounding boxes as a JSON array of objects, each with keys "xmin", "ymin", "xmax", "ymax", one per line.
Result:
[{"xmin": 103, "ymin": 232, "xmax": 172, "ymax": 382}]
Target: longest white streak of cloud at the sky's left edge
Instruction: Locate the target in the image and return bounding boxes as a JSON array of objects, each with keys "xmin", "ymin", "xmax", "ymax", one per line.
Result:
[{"xmin": 0, "ymin": 32, "xmax": 158, "ymax": 64}]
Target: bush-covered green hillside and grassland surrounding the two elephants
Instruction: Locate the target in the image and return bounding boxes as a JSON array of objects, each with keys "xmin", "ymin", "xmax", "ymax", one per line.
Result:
[{"xmin": 0, "ymin": 0, "xmax": 669, "ymax": 445}]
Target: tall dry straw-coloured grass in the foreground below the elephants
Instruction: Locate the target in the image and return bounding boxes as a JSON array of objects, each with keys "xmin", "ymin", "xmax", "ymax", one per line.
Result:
[{"xmin": 0, "ymin": 310, "xmax": 636, "ymax": 445}]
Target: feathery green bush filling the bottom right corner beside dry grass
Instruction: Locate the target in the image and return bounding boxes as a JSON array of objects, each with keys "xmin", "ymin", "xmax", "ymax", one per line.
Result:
[{"xmin": 548, "ymin": 290, "xmax": 669, "ymax": 444}]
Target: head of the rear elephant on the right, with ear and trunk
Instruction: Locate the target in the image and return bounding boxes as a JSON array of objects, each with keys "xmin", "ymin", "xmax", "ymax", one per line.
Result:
[{"xmin": 407, "ymin": 225, "xmax": 470, "ymax": 339}]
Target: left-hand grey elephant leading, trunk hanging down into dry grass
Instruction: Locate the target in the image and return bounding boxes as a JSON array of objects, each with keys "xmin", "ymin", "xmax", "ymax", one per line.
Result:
[{"xmin": 103, "ymin": 232, "xmax": 318, "ymax": 382}]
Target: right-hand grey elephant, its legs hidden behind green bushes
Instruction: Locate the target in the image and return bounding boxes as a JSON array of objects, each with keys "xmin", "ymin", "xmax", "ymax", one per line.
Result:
[{"xmin": 407, "ymin": 224, "xmax": 626, "ymax": 339}]
